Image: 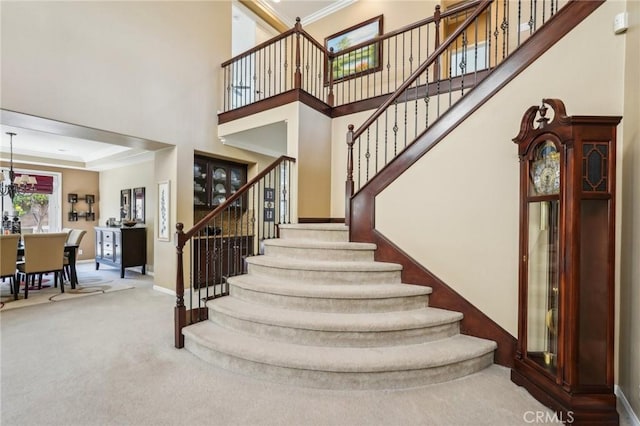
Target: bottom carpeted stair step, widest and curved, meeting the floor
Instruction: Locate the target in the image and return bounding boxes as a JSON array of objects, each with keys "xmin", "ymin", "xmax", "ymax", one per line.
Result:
[{"xmin": 183, "ymin": 321, "xmax": 496, "ymax": 389}]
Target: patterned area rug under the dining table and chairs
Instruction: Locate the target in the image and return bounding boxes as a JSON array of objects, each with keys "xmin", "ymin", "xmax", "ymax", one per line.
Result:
[{"xmin": 0, "ymin": 274, "xmax": 133, "ymax": 311}]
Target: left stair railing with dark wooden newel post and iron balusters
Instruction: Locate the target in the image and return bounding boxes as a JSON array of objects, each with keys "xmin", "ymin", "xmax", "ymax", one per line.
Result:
[{"xmin": 174, "ymin": 156, "xmax": 295, "ymax": 348}]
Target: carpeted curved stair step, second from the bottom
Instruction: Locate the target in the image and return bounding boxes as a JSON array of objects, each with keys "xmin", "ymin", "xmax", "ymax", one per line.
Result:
[{"xmin": 207, "ymin": 297, "xmax": 462, "ymax": 347}]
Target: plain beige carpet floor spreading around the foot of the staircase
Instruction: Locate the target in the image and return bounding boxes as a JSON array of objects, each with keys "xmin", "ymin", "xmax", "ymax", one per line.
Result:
[{"xmin": 0, "ymin": 265, "xmax": 631, "ymax": 426}]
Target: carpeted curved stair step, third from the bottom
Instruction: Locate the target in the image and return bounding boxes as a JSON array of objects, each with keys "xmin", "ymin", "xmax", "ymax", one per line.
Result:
[{"xmin": 228, "ymin": 275, "xmax": 431, "ymax": 313}]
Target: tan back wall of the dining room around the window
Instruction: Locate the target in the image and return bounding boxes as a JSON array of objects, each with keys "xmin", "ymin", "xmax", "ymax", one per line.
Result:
[{"xmin": 0, "ymin": 161, "xmax": 100, "ymax": 260}]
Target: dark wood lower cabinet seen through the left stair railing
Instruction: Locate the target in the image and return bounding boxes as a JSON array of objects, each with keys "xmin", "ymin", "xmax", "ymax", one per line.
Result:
[{"xmin": 193, "ymin": 236, "xmax": 253, "ymax": 288}]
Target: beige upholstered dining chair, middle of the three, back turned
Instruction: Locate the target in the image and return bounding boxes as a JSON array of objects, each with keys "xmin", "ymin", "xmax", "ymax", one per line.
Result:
[{"xmin": 14, "ymin": 232, "xmax": 67, "ymax": 299}]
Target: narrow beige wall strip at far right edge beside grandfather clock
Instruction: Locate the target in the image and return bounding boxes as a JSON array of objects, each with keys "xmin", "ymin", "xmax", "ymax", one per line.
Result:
[{"xmin": 618, "ymin": 1, "xmax": 640, "ymax": 416}]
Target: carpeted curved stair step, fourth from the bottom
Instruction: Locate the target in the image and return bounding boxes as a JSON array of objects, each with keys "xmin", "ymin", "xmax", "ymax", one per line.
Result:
[{"xmin": 246, "ymin": 256, "xmax": 402, "ymax": 285}]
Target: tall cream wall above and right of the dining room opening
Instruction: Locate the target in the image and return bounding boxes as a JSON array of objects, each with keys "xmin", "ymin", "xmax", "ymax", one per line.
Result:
[{"xmin": 0, "ymin": 1, "xmax": 278, "ymax": 288}]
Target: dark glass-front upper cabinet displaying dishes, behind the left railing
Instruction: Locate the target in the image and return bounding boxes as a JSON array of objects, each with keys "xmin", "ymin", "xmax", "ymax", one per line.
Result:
[{"xmin": 193, "ymin": 156, "xmax": 247, "ymax": 209}]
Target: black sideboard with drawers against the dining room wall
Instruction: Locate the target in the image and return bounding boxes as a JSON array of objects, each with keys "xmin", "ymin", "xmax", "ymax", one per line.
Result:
[{"xmin": 95, "ymin": 227, "xmax": 147, "ymax": 278}]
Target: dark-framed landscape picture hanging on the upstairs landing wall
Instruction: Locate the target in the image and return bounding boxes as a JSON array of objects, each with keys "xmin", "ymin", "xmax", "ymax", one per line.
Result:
[{"xmin": 324, "ymin": 15, "xmax": 382, "ymax": 82}]
